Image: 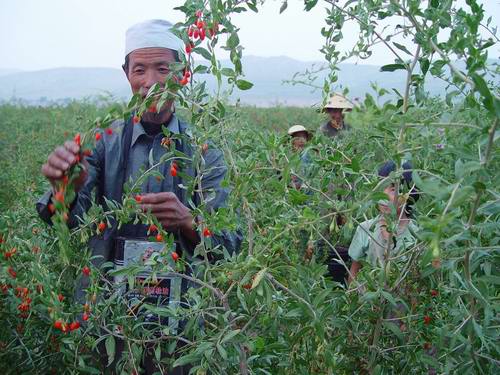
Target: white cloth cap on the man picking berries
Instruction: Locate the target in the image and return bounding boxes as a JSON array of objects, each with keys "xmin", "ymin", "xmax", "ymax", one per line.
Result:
[{"xmin": 125, "ymin": 20, "xmax": 184, "ymax": 56}]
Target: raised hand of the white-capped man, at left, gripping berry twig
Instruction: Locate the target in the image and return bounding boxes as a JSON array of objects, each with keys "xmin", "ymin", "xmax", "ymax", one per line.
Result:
[{"xmin": 42, "ymin": 141, "xmax": 88, "ymax": 191}]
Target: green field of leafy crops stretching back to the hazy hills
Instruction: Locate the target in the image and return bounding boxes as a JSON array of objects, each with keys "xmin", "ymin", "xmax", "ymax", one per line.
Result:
[{"xmin": 0, "ymin": 93, "xmax": 500, "ymax": 374}]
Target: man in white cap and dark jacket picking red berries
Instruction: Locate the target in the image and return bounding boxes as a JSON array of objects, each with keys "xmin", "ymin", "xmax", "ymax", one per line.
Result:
[{"xmin": 37, "ymin": 20, "xmax": 241, "ymax": 374}]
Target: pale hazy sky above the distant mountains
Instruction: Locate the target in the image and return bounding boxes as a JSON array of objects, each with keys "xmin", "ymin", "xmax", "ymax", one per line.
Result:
[{"xmin": 0, "ymin": 0, "xmax": 500, "ymax": 70}]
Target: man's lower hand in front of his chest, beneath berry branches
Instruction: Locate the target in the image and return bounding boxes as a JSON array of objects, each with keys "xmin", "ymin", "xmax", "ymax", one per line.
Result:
[{"xmin": 141, "ymin": 192, "xmax": 200, "ymax": 245}]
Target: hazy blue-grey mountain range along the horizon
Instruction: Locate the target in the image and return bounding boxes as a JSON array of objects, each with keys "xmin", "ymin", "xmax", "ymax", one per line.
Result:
[{"xmin": 0, "ymin": 56, "xmax": 498, "ymax": 106}]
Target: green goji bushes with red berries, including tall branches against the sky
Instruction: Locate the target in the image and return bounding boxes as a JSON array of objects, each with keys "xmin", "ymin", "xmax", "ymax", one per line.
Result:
[{"xmin": 0, "ymin": 0, "xmax": 500, "ymax": 374}]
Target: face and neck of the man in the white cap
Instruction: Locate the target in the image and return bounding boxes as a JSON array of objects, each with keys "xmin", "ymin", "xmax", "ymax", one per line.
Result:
[{"xmin": 125, "ymin": 48, "xmax": 175, "ymax": 122}]
